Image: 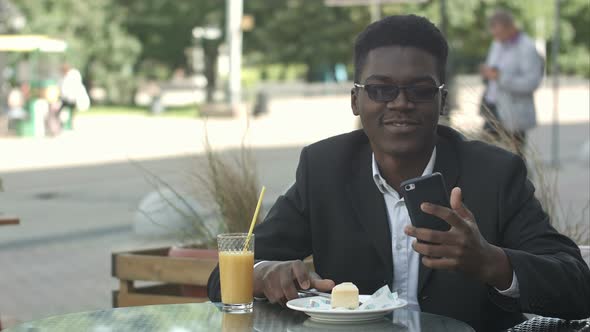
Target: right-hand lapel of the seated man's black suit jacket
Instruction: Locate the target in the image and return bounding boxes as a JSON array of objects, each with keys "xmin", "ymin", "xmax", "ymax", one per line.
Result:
[{"xmin": 418, "ymin": 131, "xmax": 460, "ymax": 295}]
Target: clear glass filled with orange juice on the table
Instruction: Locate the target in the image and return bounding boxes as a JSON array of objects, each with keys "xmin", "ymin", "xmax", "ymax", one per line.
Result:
[{"xmin": 217, "ymin": 233, "xmax": 254, "ymax": 313}]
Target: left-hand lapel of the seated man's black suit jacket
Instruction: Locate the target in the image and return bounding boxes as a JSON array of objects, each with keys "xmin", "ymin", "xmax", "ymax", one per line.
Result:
[{"xmin": 346, "ymin": 143, "xmax": 393, "ymax": 280}]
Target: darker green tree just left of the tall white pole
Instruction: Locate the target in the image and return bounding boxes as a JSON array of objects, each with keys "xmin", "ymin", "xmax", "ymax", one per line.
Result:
[{"xmin": 121, "ymin": 0, "xmax": 225, "ymax": 101}]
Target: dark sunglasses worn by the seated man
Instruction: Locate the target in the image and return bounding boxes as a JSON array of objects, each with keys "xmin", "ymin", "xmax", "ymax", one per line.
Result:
[{"xmin": 354, "ymin": 83, "xmax": 445, "ymax": 103}]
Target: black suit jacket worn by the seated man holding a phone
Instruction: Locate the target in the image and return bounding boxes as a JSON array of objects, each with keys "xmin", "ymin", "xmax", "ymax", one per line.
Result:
[{"xmin": 208, "ymin": 126, "xmax": 590, "ymax": 331}]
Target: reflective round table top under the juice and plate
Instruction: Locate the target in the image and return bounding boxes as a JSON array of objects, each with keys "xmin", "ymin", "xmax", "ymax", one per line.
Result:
[{"xmin": 4, "ymin": 302, "xmax": 473, "ymax": 332}]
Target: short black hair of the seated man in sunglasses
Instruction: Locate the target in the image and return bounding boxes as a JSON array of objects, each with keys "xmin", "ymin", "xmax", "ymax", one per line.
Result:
[{"xmin": 354, "ymin": 15, "xmax": 449, "ymax": 83}]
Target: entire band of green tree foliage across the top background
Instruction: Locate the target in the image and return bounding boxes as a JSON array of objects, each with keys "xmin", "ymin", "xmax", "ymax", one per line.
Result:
[{"xmin": 11, "ymin": 0, "xmax": 590, "ymax": 101}]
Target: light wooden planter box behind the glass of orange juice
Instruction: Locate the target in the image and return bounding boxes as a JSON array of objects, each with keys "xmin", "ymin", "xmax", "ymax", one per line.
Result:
[{"xmin": 111, "ymin": 248, "xmax": 217, "ymax": 308}]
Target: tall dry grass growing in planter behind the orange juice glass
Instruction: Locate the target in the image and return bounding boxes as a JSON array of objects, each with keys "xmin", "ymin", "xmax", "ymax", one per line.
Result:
[{"xmin": 132, "ymin": 122, "xmax": 264, "ymax": 248}]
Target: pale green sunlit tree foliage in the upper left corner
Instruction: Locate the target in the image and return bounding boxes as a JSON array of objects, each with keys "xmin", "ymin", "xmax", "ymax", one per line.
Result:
[{"xmin": 13, "ymin": 0, "xmax": 141, "ymax": 102}]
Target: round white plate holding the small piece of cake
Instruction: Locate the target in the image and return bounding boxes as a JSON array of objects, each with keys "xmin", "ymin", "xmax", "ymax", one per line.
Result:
[{"xmin": 287, "ymin": 295, "xmax": 408, "ymax": 323}]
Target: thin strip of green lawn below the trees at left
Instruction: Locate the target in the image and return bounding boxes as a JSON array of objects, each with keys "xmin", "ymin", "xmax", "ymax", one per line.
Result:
[{"xmin": 78, "ymin": 105, "xmax": 199, "ymax": 118}]
